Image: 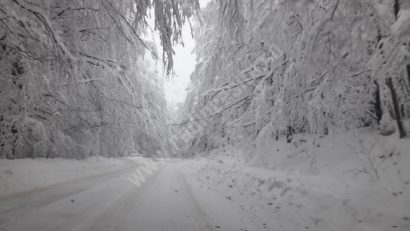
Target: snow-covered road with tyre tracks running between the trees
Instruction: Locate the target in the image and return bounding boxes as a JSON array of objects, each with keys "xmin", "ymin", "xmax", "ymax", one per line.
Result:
[{"xmin": 0, "ymin": 161, "xmax": 241, "ymax": 231}]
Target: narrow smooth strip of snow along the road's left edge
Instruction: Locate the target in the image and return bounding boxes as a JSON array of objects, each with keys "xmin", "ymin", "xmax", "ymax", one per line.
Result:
[{"xmin": 0, "ymin": 157, "xmax": 138, "ymax": 196}]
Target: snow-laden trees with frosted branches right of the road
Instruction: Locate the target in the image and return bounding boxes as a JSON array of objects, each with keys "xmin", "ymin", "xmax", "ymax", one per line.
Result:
[{"xmin": 182, "ymin": 0, "xmax": 410, "ymax": 155}]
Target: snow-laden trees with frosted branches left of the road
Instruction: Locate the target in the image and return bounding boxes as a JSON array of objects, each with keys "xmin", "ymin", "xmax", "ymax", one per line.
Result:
[{"xmin": 0, "ymin": 0, "xmax": 198, "ymax": 158}]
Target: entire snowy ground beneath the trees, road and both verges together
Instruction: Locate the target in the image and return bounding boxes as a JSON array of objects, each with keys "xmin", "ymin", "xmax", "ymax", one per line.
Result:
[{"xmin": 0, "ymin": 129, "xmax": 410, "ymax": 231}]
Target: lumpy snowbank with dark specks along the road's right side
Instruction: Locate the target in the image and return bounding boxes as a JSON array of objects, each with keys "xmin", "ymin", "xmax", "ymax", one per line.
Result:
[{"xmin": 181, "ymin": 130, "xmax": 410, "ymax": 231}]
